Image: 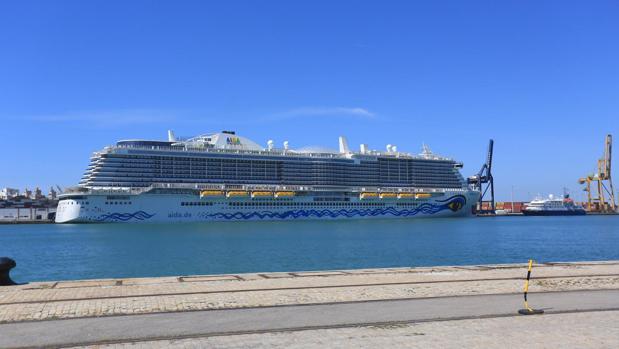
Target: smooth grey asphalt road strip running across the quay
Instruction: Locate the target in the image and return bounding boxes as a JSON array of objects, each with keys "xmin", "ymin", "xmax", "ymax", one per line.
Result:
[{"xmin": 0, "ymin": 290, "xmax": 619, "ymax": 348}]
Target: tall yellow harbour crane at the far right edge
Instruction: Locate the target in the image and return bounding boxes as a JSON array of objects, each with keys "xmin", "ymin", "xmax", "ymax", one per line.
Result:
[{"xmin": 578, "ymin": 135, "xmax": 617, "ymax": 213}]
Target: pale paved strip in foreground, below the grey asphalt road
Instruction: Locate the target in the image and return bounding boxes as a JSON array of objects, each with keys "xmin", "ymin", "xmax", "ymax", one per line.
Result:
[{"xmin": 71, "ymin": 311, "xmax": 619, "ymax": 349}]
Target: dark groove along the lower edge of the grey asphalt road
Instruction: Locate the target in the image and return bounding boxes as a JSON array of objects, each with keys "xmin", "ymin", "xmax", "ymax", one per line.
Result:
[{"xmin": 24, "ymin": 307, "xmax": 619, "ymax": 349}]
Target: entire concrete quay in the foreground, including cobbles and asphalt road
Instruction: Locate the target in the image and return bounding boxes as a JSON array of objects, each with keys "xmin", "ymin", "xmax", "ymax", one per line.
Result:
[{"xmin": 0, "ymin": 261, "xmax": 619, "ymax": 348}]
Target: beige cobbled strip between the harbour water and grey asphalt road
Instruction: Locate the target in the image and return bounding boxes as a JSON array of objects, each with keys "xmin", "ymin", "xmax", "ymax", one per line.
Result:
[{"xmin": 0, "ymin": 262, "xmax": 619, "ymax": 323}]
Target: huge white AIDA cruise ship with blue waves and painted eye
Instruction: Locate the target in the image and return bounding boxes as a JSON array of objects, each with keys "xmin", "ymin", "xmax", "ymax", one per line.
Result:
[{"xmin": 56, "ymin": 131, "xmax": 480, "ymax": 223}]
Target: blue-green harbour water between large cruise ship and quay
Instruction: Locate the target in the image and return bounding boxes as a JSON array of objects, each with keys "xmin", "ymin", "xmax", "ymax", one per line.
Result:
[{"xmin": 0, "ymin": 216, "xmax": 619, "ymax": 282}]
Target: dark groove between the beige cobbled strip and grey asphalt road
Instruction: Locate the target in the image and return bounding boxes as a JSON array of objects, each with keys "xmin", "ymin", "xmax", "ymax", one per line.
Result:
[{"xmin": 0, "ymin": 288, "xmax": 619, "ymax": 325}]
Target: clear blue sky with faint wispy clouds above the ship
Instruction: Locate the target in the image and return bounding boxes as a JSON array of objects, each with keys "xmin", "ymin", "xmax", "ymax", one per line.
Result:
[{"xmin": 0, "ymin": 0, "xmax": 619, "ymax": 200}]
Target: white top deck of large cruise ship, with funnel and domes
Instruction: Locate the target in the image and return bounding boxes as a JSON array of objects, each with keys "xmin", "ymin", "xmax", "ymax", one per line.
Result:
[{"xmin": 112, "ymin": 131, "xmax": 454, "ymax": 161}]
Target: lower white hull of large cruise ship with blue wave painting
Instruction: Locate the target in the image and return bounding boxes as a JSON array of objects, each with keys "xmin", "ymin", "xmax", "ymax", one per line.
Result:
[{"xmin": 56, "ymin": 190, "xmax": 479, "ymax": 223}]
